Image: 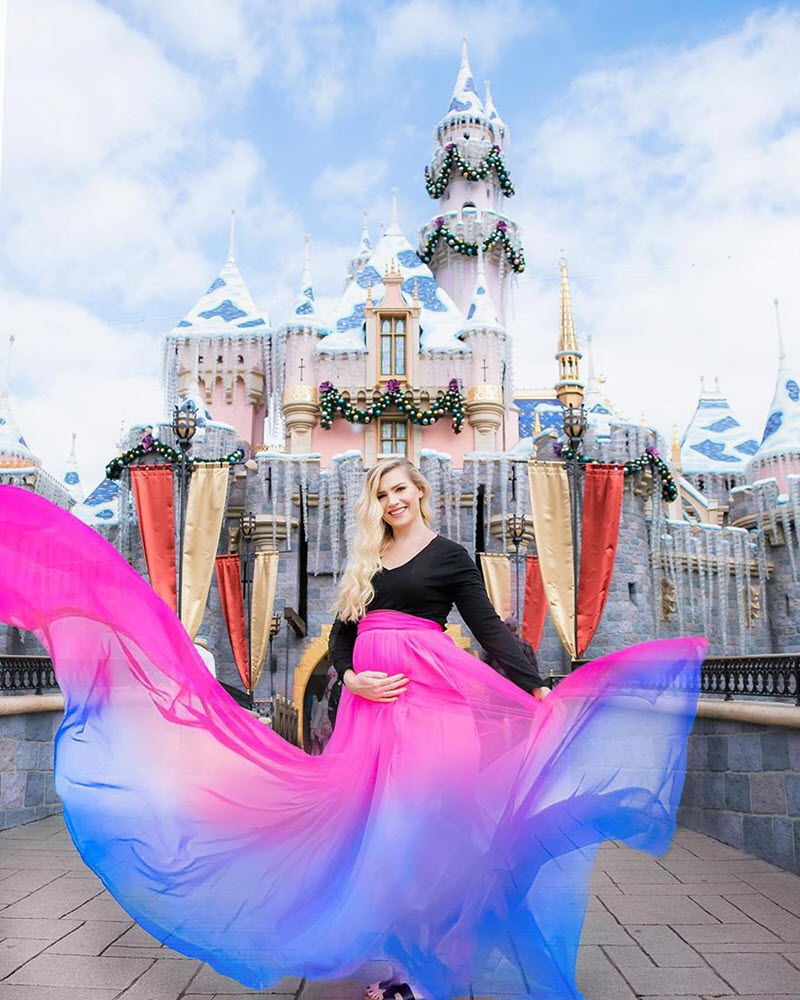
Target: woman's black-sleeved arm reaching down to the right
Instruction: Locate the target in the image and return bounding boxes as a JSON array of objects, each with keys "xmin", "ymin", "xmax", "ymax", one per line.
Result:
[{"xmin": 453, "ymin": 546, "xmax": 545, "ymax": 692}]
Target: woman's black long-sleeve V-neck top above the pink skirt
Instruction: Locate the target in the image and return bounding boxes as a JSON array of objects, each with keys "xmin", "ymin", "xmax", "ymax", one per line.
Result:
[{"xmin": 330, "ymin": 535, "xmax": 544, "ymax": 691}]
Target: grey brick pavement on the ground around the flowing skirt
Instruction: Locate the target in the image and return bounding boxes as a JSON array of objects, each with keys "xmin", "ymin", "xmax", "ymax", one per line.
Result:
[{"xmin": 0, "ymin": 816, "xmax": 800, "ymax": 1000}]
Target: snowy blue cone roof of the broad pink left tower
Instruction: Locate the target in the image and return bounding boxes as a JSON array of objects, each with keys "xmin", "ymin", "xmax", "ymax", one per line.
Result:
[{"xmin": 171, "ymin": 214, "xmax": 270, "ymax": 337}]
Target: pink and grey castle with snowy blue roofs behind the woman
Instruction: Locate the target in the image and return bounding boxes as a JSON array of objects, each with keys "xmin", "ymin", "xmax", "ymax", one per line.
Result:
[{"xmin": 0, "ymin": 45, "xmax": 800, "ymax": 728}]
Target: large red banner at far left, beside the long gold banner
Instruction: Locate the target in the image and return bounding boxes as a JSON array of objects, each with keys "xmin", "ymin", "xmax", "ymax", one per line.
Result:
[{"xmin": 129, "ymin": 465, "xmax": 178, "ymax": 611}]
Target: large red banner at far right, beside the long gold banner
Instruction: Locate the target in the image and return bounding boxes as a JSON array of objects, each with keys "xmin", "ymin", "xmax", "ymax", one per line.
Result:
[{"xmin": 578, "ymin": 463, "xmax": 624, "ymax": 656}]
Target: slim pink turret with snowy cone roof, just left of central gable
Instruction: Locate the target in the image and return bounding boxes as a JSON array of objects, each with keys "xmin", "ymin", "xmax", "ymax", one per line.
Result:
[{"xmin": 276, "ymin": 234, "xmax": 328, "ymax": 454}]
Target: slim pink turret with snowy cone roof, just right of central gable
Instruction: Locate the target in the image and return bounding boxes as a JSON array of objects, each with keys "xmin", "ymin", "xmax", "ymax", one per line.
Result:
[{"xmin": 463, "ymin": 247, "xmax": 509, "ymax": 451}]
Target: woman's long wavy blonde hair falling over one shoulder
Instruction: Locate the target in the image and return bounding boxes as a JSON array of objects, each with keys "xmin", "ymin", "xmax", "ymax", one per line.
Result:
[{"xmin": 333, "ymin": 458, "xmax": 433, "ymax": 621}]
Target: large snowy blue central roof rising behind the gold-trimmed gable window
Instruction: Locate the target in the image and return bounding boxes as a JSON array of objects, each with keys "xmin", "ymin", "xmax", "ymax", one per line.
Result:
[{"xmin": 317, "ymin": 191, "xmax": 469, "ymax": 352}]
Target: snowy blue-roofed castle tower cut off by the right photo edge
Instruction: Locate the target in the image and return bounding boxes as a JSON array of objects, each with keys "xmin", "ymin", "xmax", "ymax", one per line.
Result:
[{"xmin": 747, "ymin": 300, "xmax": 800, "ymax": 493}]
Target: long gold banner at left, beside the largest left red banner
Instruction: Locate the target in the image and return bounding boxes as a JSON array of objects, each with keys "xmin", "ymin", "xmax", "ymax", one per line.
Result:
[{"xmin": 181, "ymin": 463, "xmax": 230, "ymax": 639}]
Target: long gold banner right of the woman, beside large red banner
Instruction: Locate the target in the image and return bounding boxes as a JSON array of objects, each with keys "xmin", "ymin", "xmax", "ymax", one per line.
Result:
[{"xmin": 528, "ymin": 462, "xmax": 576, "ymax": 658}]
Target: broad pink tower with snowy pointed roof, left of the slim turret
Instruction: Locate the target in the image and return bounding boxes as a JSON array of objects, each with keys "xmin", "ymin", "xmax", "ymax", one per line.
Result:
[{"xmin": 163, "ymin": 213, "xmax": 272, "ymax": 448}]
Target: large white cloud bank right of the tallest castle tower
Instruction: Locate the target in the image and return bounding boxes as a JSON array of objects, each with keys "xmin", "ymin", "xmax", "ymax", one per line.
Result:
[{"xmin": 512, "ymin": 11, "xmax": 800, "ymax": 446}]
